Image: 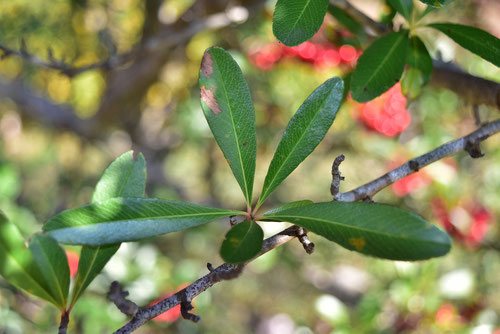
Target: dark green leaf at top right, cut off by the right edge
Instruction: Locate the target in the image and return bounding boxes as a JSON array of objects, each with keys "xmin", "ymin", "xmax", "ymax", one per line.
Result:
[{"xmin": 429, "ymin": 23, "xmax": 500, "ymax": 67}]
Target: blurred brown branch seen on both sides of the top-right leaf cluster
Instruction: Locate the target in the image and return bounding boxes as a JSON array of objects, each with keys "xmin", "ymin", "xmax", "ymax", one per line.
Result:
[{"xmin": 330, "ymin": 0, "xmax": 500, "ymax": 110}]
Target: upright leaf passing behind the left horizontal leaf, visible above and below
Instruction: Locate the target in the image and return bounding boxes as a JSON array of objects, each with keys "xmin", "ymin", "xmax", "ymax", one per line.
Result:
[{"xmin": 71, "ymin": 151, "xmax": 146, "ymax": 305}]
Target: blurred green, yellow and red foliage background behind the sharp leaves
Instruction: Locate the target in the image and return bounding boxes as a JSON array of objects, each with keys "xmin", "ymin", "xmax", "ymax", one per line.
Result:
[{"xmin": 0, "ymin": 0, "xmax": 500, "ymax": 334}]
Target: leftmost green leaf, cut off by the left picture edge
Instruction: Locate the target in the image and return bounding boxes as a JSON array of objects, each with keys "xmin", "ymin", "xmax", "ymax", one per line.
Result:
[{"xmin": 0, "ymin": 211, "xmax": 59, "ymax": 306}]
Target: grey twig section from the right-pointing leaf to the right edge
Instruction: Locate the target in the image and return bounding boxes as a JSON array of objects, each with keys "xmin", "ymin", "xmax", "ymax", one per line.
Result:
[{"xmin": 334, "ymin": 119, "xmax": 500, "ymax": 202}]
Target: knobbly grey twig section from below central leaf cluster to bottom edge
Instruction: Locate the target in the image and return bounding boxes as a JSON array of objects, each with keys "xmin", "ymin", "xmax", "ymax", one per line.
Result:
[{"xmin": 115, "ymin": 226, "xmax": 310, "ymax": 334}]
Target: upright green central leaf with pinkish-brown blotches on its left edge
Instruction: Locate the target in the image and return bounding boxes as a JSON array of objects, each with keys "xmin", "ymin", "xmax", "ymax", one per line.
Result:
[{"xmin": 199, "ymin": 47, "xmax": 257, "ymax": 206}]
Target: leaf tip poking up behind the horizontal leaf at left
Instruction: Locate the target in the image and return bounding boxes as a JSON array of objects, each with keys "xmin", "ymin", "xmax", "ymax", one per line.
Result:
[{"xmin": 92, "ymin": 151, "xmax": 146, "ymax": 203}]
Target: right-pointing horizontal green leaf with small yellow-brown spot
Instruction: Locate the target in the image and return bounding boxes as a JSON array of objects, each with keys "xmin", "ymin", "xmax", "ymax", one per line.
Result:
[{"xmin": 263, "ymin": 202, "xmax": 451, "ymax": 261}]
